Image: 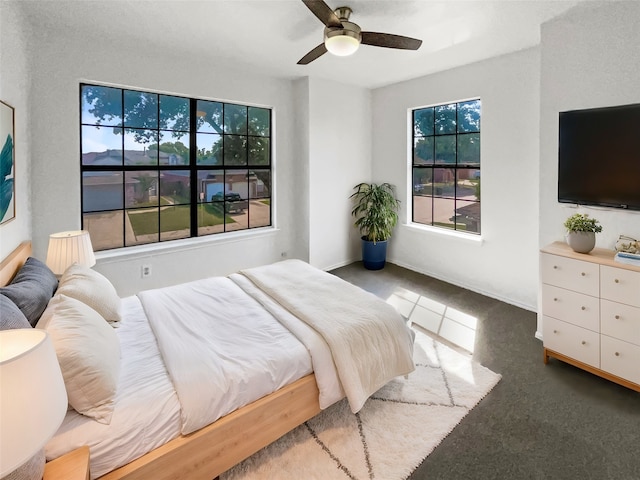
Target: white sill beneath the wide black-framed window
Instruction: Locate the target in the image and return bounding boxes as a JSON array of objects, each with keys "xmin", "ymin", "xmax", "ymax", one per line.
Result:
[{"xmin": 95, "ymin": 227, "xmax": 278, "ymax": 264}]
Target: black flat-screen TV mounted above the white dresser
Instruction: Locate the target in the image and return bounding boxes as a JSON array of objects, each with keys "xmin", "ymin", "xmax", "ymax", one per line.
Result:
[{"xmin": 558, "ymin": 104, "xmax": 640, "ymax": 210}]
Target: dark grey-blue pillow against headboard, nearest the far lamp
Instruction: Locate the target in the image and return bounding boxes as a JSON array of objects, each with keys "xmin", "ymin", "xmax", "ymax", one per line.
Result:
[{"xmin": 0, "ymin": 257, "xmax": 58, "ymax": 326}]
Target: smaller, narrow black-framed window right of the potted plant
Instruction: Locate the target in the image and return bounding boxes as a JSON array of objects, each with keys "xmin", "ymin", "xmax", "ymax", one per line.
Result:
[{"xmin": 412, "ymin": 100, "xmax": 480, "ymax": 234}]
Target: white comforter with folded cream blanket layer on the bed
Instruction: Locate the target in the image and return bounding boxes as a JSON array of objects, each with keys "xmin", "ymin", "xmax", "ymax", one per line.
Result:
[{"xmin": 138, "ymin": 260, "xmax": 414, "ymax": 434}]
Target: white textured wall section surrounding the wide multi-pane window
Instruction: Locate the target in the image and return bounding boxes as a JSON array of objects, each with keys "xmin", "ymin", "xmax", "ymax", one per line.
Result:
[{"xmin": 28, "ymin": 29, "xmax": 307, "ymax": 295}]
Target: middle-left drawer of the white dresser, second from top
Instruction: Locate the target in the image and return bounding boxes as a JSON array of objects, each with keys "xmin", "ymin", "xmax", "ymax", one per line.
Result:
[{"xmin": 542, "ymin": 284, "xmax": 600, "ymax": 332}]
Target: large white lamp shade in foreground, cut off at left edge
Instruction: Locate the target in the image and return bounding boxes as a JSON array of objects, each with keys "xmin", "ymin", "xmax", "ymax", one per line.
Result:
[{"xmin": 0, "ymin": 328, "xmax": 67, "ymax": 477}]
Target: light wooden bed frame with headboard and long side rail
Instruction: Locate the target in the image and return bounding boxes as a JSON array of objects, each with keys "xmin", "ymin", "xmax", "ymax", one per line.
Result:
[{"xmin": 0, "ymin": 242, "xmax": 320, "ymax": 480}]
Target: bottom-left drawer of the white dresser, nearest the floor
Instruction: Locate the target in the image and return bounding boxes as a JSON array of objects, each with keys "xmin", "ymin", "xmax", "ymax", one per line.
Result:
[{"xmin": 542, "ymin": 316, "xmax": 600, "ymax": 368}]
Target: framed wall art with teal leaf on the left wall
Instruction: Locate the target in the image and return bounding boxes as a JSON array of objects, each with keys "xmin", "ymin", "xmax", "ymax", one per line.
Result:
[{"xmin": 0, "ymin": 100, "xmax": 16, "ymax": 224}]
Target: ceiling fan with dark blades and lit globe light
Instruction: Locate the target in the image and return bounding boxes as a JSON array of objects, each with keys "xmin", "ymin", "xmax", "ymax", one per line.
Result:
[{"xmin": 298, "ymin": 0, "xmax": 422, "ymax": 65}]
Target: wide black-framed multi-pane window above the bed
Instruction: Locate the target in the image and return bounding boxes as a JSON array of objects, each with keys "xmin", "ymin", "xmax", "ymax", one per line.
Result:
[{"xmin": 80, "ymin": 84, "xmax": 272, "ymax": 250}]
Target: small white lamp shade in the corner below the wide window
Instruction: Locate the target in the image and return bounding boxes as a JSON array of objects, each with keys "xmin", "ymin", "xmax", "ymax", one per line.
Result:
[{"xmin": 47, "ymin": 230, "xmax": 96, "ymax": 275}]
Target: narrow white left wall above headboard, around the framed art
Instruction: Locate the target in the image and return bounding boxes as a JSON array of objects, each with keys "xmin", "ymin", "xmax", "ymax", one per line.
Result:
[{"xmin": 0, "ymin": 2, "xmax": 32, "ymax": 259}]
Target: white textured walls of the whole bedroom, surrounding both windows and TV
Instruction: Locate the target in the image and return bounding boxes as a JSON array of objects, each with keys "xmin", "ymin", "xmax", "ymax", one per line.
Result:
[{"xmin": 8, "ymin": 2, "xmax": 640, "ymax": 316}]
